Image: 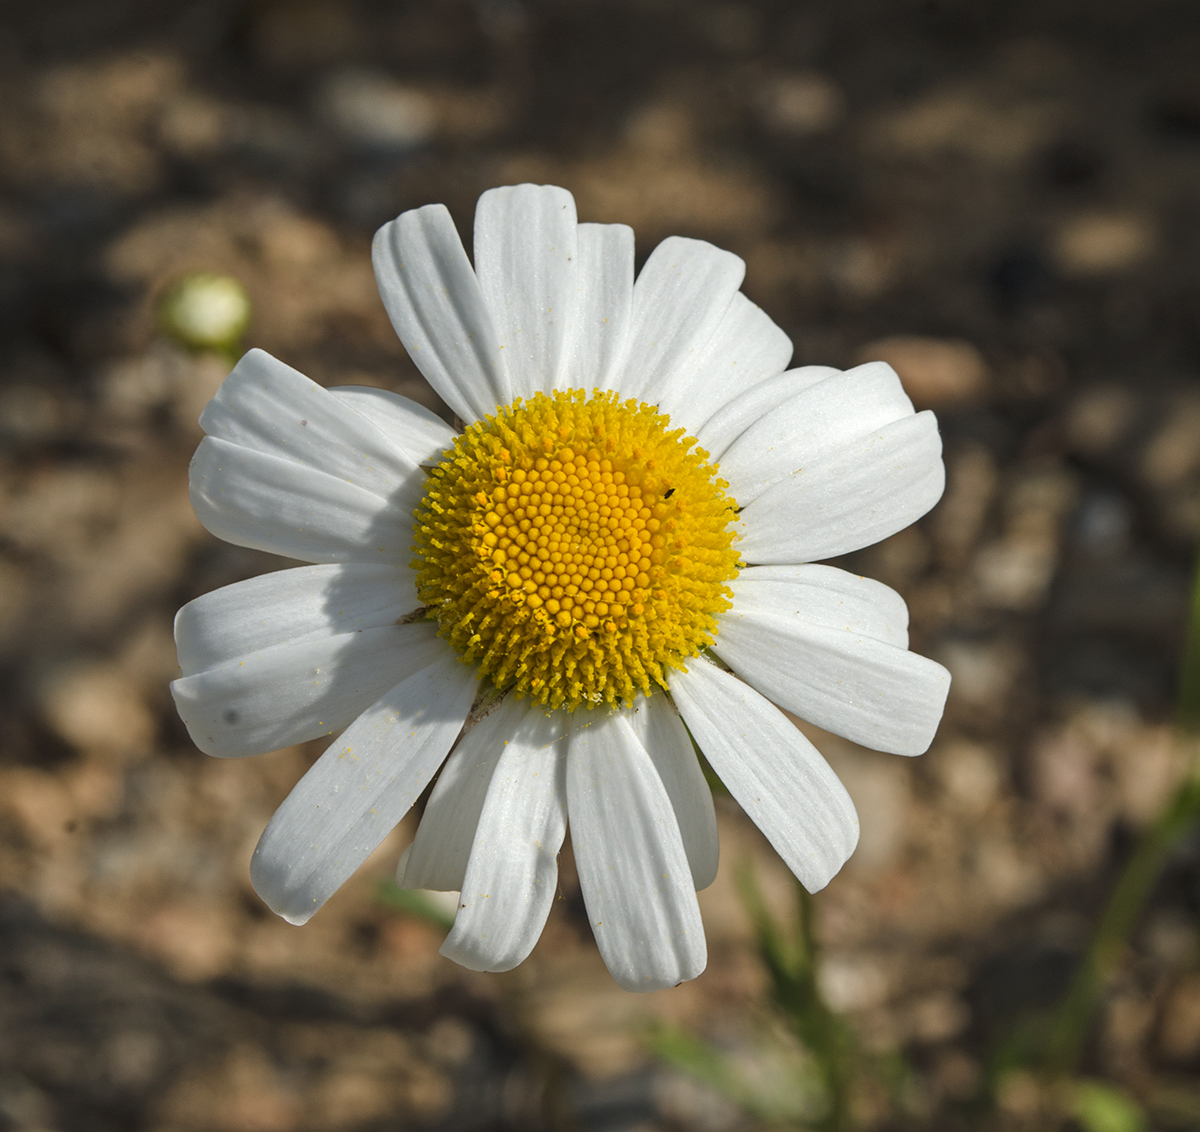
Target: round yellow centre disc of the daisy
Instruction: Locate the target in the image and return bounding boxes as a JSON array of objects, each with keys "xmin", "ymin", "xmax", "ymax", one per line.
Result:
[{"xmin": 413, "ymin": 390, "xmax": 738, "ymax": 711}]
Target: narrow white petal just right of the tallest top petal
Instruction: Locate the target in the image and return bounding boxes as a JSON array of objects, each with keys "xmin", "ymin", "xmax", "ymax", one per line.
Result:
[{"xmin": 568, "ymin": 224, "xmax": 634, "ymax": 393}]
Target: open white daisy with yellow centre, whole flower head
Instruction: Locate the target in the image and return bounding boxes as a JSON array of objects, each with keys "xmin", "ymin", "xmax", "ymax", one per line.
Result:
[{"xmin": 172, "ymin": 185, "xmax": 949, "ymax": 990}]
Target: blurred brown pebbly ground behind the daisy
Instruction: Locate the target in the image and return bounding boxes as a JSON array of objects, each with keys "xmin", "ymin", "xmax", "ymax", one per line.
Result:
[{"xmin": 0, "ymin": 0, "xmax": 1200, "ymax": 1132}]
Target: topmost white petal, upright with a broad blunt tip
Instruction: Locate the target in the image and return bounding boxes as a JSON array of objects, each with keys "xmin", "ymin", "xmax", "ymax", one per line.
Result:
[{"xmin": 474, "ymin": 185, "xmax": 578, "ymax": 397}]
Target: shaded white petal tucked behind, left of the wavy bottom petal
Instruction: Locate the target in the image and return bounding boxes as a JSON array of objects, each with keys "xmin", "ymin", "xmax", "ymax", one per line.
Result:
[{"xmin": 397, "ymin": 697, "xmax": 522, "ymax": 892}]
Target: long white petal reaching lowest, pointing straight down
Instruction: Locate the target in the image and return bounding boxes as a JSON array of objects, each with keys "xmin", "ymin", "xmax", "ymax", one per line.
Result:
[{"xmin": 566, "ymin": 711, "xmax": 708, "ymax": 990}]
